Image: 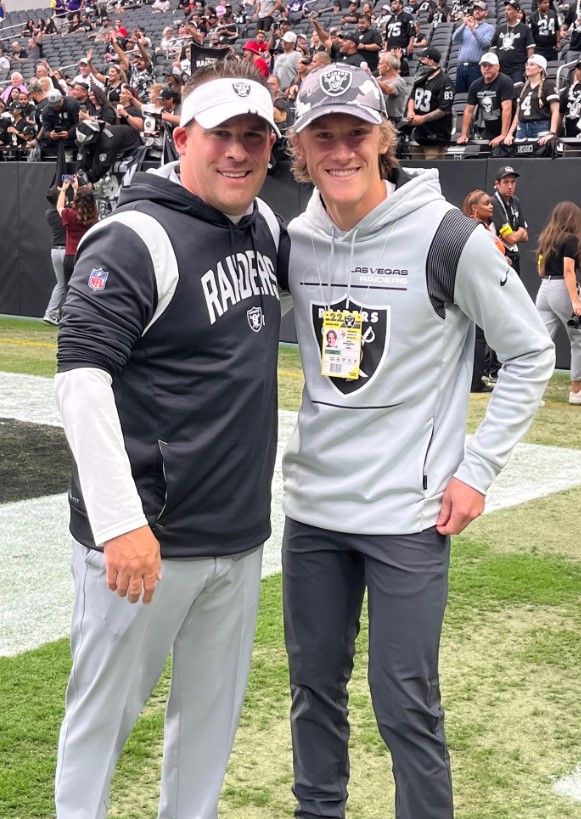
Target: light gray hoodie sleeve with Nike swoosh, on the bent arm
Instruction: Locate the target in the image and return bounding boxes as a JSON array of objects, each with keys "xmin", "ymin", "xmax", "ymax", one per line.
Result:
[{"xmin": 454, "ymin": 227, "xmax": 555, "ymax": 493}]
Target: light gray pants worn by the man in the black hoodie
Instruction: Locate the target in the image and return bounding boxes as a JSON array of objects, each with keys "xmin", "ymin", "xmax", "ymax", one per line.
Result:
[{"xmin": 55, "ymin": 543, "xmax": 262, "ymax": 819}]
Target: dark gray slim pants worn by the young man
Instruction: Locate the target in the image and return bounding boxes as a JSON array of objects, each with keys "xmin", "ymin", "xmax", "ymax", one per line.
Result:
[{"xmin": 283, "ymin": 520, "xmax": 454, "ymax": 819}]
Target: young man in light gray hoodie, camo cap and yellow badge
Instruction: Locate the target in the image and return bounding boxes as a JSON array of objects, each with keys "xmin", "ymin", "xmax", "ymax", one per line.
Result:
[{"xmin": 283, "ymin": 64, "xmax": 554, "ymax": 819}]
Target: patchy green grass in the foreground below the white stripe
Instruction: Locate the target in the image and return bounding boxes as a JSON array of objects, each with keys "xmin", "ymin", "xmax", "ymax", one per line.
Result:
[{"xmin": 0, "ymin": 524, "xmax": 581, "ymax": 819}]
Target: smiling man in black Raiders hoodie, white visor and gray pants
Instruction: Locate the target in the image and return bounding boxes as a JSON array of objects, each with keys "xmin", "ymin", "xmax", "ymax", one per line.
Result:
[{"xmin": 56, "ymin": 61, "xmax": 287, "ymax": 819}]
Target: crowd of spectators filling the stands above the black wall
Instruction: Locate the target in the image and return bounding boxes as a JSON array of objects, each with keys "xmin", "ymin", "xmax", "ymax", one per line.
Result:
[{"xmin": 0, "ymin": 0, "xmax": 581, "ymax": 174}]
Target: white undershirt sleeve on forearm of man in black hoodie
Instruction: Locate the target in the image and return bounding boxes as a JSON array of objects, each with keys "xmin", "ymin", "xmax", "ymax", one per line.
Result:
[{"xmin": 55, "ymin": 367, "xmax": 147, "ymax": 549}]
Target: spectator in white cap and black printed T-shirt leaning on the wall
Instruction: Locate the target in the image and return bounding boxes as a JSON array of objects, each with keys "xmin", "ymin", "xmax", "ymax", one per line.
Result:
[{"xmin": 457, "ymin": 52, "xmax": 515, "ymax": 148}]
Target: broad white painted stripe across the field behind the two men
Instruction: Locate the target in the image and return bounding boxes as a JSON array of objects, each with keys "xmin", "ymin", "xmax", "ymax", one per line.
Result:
[{"xmin": 0, "ymin": 373, "xmax": 581, "ymax": 656}]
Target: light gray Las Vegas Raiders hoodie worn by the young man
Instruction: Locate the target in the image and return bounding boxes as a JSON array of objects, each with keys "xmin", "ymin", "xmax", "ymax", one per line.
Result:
[{"xmin": 283, "ymin": 170, "xmax": 555, "ymax": 534}]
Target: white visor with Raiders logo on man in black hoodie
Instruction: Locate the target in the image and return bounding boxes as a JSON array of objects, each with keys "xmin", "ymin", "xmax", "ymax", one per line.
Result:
[{"xmin": 180, "ymin": 78, "xmax": 280, "ymax": 136}]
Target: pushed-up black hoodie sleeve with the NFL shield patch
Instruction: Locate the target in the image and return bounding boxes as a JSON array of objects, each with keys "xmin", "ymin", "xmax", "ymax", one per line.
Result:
[{"xmin": 57, "ymin": 219, "xmax": 157, "ymax": 376}]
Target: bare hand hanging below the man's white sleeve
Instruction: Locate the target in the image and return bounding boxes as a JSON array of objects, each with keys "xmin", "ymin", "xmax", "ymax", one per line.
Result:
[{"xmin": 104, "ymin": 526, "xmax": 161, "ymax": 605}]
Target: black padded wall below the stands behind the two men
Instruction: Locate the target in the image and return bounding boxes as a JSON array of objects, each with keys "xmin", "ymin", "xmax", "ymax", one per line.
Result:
[{"xmin": 0, "ymin": 158, "xmax": 581, "ymax": 369}]
